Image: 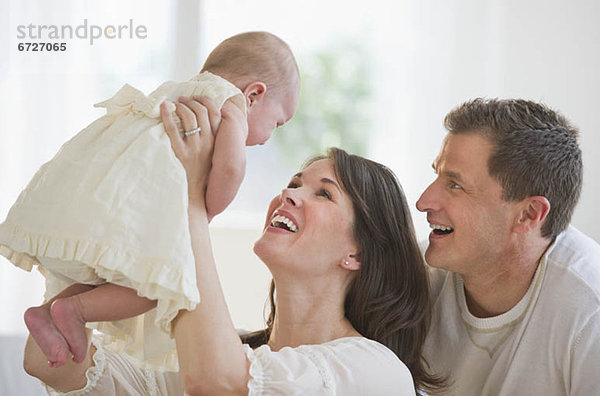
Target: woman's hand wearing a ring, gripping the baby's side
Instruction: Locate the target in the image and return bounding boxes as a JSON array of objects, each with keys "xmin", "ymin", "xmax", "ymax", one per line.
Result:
[{"xmin": 160, "ymin": 97, "xmax": 220, "ymax": 204}]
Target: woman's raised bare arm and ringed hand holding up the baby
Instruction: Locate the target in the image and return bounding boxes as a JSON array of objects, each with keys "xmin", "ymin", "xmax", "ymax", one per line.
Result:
[{"xmin": 166, "ymin": 97, "xmax": 249, "ymax": 395}]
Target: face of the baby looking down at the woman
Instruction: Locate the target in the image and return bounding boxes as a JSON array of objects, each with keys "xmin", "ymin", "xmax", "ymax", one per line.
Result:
[{"xmin": 246, "ymin": 85, "xmax": 300, "ymax": 146}]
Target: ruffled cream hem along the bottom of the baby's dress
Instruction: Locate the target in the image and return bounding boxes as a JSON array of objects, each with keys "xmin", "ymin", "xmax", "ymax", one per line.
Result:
[{"xmin": 0, "ymin": 223, "xmax": 200, "ymax": 336}]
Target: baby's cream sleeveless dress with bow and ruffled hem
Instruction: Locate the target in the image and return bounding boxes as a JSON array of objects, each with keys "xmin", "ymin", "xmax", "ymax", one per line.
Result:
[{"xmin": 0, "ymin": 72, "xmax": 245, "ymax": 371}]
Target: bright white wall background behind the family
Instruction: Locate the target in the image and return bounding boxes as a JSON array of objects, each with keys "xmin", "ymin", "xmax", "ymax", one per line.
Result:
[{"xmin": 0, "ymin": 0, "xmax": 600, "ymax": 334}]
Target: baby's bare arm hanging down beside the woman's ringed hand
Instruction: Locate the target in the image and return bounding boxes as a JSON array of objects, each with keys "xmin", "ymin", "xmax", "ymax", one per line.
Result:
[{"xmin": 206, "ymin": 100, "xmax": 248, "ymax": 219}]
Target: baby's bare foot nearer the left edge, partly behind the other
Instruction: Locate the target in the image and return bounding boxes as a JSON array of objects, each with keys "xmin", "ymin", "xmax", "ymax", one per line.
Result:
[{"xmin": 24, "ymin": 307, "xmax": 70, "ymax": 367}]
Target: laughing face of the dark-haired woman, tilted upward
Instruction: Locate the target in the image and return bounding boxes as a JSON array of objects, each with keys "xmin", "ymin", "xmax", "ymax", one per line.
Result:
[{"xmin": 254, "ymin": 159, "xmax": 358, "ymax": 277}]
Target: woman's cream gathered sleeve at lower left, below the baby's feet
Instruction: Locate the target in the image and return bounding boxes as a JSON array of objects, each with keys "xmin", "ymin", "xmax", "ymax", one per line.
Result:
[{"xmin": 46, "ymin": 339, "xmax": 184, "ymax": 396}]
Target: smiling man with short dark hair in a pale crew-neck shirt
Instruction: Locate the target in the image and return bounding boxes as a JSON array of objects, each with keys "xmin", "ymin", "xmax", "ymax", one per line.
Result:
[{"xmin": 417, "ymin": 99, "xmax": 600, "ymax": 396}]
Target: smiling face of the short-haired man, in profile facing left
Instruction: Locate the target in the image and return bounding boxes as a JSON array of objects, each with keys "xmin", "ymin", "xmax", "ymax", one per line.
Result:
[{"xmin": 417, "ymin": 134, "xmax": 517, "ymax": 275}]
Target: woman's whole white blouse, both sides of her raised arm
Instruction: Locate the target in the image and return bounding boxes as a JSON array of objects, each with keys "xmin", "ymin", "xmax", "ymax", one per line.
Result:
[{"xmin": 47, "ymin": 337, "xmax": 415, "ymax": 396}]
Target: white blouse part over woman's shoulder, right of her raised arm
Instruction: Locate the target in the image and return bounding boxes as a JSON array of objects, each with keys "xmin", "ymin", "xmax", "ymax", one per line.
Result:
[{"xmin": 245, "ymin": 337, "xmax": 415, "ymax": 396}]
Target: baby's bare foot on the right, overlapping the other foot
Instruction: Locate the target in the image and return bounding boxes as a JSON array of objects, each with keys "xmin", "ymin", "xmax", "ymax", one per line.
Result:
[{"xmin": 50, "ymin": 297, "xmax": 89, "ymax": 363}]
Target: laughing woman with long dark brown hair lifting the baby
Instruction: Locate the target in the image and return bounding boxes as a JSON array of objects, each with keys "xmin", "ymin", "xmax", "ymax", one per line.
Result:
[{"xmin": 25, "ymin": 99, "xmax": 438, "ymax": 395}]
